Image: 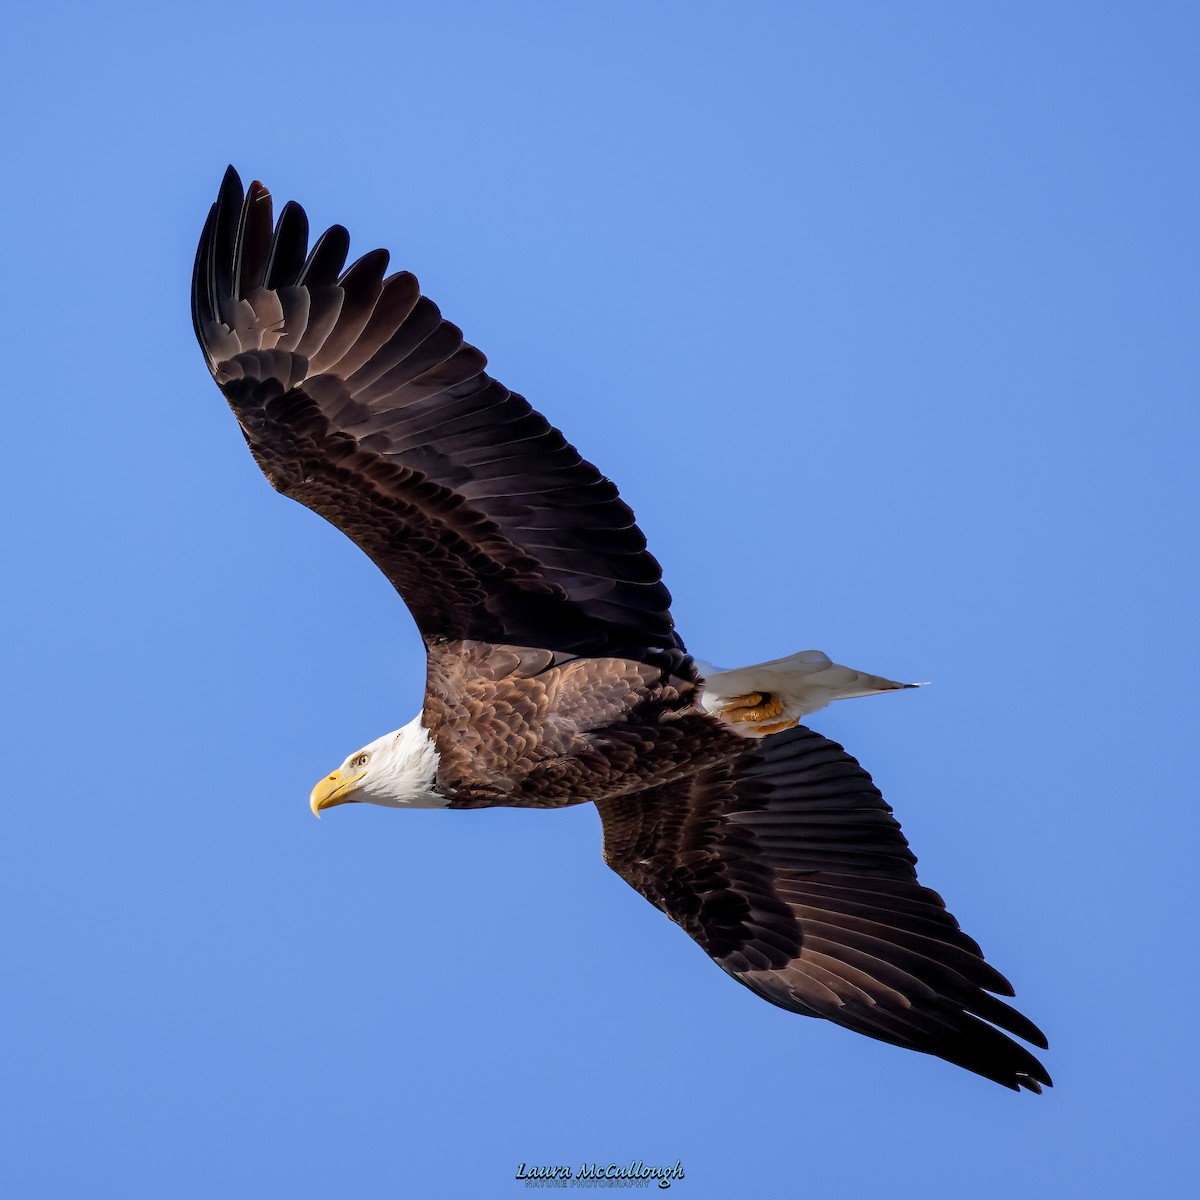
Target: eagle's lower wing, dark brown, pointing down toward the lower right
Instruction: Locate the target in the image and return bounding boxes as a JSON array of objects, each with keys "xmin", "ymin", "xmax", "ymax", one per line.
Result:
[{"xmin": 598, "ymin": 726, "xmax": 1050, "ymax": 1092}]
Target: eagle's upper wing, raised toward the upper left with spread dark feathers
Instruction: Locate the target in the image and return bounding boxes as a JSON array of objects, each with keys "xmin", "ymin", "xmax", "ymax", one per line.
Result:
[{"xmin": 192, "ymin": 167, "xmax": 680, "ymax": 654}]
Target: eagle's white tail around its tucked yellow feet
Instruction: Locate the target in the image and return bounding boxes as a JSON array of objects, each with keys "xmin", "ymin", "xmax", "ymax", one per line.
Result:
[{"xmin": 696, "ymin": 650, "xmax": 922, "ymax": 738}]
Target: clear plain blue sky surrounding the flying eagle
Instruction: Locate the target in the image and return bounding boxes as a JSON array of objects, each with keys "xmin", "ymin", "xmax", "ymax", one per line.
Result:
[{"xmin": 0, "ymin": 0, "xmax": 1200, "ymax": 1200}]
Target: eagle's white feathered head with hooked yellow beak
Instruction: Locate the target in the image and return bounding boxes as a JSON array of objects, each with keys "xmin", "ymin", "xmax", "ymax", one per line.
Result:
[{"xmin": 308, "ymin": 716, "xmax": 450, "ymax": 817}]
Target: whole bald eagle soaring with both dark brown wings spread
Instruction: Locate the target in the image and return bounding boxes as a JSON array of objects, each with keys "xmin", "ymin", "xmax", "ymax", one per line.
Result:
[{"xmin": 192, "ymin": 167, "xmax": 1050, "ymax": 1092}]
